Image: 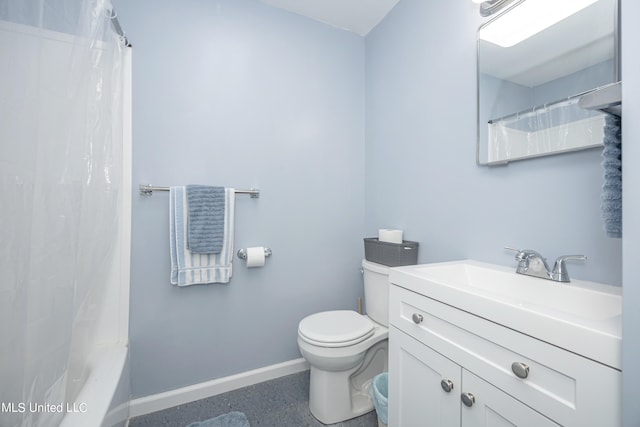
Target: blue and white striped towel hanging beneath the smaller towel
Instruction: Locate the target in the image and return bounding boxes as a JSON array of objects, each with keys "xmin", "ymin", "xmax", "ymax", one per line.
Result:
[{"xmin": 169, "ymin": 187, "xmax": 235, "ymax": 286}]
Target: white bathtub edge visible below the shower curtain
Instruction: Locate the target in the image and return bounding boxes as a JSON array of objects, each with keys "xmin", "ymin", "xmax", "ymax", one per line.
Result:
[{"xmin": 60, "ymin": 344, "xmax": 130, "ymax": 427}]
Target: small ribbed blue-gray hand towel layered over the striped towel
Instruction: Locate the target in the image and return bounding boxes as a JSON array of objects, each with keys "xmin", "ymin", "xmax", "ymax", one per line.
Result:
[{"xmin": 186, "ymin": 185, "xmax": 225, "ymax": 254}]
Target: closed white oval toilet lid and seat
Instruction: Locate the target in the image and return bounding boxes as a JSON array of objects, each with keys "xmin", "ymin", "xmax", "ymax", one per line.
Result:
[{"xmin": 298, "ymin": 310, "xmax": 375, "ymax": 347}]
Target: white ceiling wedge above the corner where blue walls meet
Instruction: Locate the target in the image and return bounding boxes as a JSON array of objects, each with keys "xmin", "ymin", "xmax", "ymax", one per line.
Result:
[{"xmin": 260, "ymin": 0, "xmax": 399, "ymax": 36}]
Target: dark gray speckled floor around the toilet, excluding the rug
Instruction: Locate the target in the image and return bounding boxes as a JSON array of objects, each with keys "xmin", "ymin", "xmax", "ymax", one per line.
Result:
[{"xmin": 129, "ymin": 371, "xmax": 378, "ymax": 427}]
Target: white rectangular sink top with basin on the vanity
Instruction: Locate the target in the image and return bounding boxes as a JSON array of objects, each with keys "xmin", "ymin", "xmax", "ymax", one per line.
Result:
[{"xmin": 389, "ymin": 260, "xmax": 622, "ymax": 369}]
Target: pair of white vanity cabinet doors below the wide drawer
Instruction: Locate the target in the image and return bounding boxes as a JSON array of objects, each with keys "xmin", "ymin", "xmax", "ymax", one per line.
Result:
[{"xmin": 389, "ymin": 328, "xmax": 558, "ymax": 427}]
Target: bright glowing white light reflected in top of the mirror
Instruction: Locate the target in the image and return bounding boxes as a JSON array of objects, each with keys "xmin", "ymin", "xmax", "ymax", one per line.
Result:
[{"xmin": 474, "ymin": 0, "xmax": 598, "ymax": 47}]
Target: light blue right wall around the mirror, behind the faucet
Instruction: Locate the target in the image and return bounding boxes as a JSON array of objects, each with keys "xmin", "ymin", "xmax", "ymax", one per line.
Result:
[{"xmin": 365, "ymin": 0, "xmax": 622, "ymax": 285}]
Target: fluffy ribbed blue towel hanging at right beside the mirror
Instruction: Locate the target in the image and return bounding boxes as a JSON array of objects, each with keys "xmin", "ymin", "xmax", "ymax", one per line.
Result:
[{"xmin": 600, "ymin": 114, "xmax": 622, "ymax": 237}]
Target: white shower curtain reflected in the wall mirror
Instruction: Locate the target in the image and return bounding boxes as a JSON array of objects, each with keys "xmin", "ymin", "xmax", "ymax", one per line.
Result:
[{"xmin": 487, "ymin": 97, "xmax": 605, "ymax": 163}]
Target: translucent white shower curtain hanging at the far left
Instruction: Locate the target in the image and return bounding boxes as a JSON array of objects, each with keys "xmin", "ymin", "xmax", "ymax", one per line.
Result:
[{"xmin": 0, "ymin": 0, "xmax": 124, "ymax": 427}]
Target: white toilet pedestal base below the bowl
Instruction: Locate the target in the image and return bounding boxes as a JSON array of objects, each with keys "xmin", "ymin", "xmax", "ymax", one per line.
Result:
[{"xmin": 309, "ymin": 340, "xmax": 388, "ymax": 424}]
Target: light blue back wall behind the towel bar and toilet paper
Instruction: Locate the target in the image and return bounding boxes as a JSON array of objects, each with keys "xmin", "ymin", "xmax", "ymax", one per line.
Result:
[{"xmin": 115, "ymin": 0, "xmax": 364, "ymax": 397}]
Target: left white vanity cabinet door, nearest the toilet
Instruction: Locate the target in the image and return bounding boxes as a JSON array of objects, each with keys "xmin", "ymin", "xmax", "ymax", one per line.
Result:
[{"xmin": 389, "ymin": 327, "xmax": 462, "ymax": 427}]
